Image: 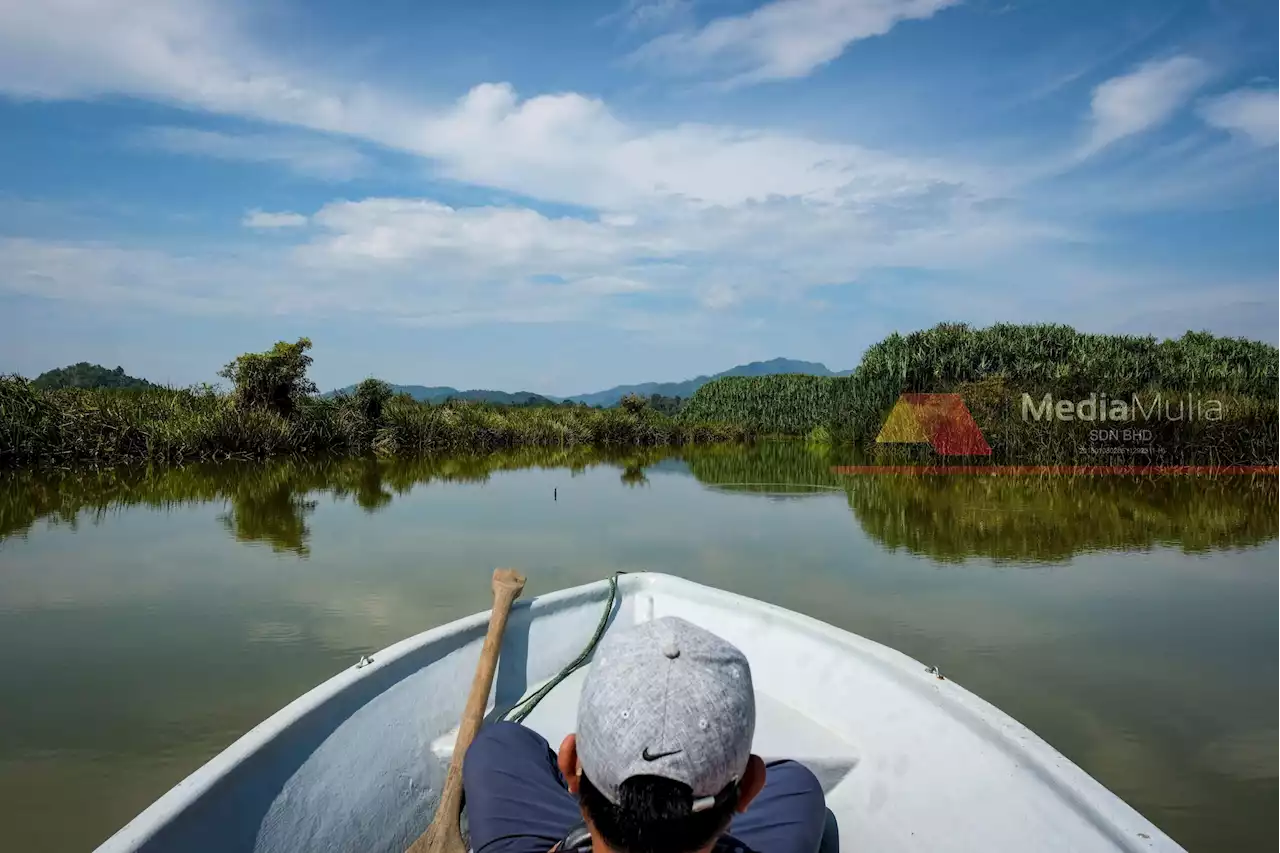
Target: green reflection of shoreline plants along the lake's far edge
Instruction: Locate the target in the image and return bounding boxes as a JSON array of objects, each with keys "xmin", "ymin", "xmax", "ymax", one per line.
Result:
[{"xmin": 0, "ymin": 443, "xmax": 1280, "ymax": 564}]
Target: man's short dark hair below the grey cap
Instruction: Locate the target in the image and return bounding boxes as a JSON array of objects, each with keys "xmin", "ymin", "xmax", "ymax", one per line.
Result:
[{"xmin": 577, "ymin": 775, "xmax": 737, "ymax": 853}]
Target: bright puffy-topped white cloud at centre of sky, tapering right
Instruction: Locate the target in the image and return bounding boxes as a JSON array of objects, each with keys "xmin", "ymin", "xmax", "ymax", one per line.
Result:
[{"xmin": 411, "ymin": 83, "xmax": 972, "ymax": 209}]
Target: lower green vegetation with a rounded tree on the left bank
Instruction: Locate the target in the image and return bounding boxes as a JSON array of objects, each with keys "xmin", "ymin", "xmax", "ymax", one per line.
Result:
[{"xmin": 0, "ymin": 338, "xmax": 749, "ymax": 467}]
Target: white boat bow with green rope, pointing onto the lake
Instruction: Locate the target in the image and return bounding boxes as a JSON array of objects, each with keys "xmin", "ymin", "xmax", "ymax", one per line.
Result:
[{"xmin": 99, "ymin": 574, "xmax": 1181, "ymax": 853}]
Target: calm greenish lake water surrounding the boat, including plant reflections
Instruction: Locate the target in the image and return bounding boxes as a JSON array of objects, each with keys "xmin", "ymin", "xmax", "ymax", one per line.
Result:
[{"xmin": 0, "ymin": 443, "xmax": 1280, "ymax": 852}]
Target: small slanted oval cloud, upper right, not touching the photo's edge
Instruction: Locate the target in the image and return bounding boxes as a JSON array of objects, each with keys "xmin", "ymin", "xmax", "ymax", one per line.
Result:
[{"xmin": 1082, "ymin": 56, "xmax": 1211, "ymax": 156}]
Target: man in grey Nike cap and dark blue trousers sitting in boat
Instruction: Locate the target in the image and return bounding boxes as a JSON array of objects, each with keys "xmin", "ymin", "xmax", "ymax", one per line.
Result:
[{"xmin": 462, "ymin": 617, "xmax": 827, "ymax": 853}]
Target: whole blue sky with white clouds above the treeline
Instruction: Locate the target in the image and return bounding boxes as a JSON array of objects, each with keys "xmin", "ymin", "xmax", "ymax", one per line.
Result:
[{"xmin": 0, "ymin": 0, "xmax": 1280, "ymax": 394}]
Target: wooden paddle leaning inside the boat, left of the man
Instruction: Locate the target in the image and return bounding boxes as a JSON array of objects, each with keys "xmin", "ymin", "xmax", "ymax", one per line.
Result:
[{"xmin": 408, "ymin": 569, "xmax": 525, "ymax": 853}]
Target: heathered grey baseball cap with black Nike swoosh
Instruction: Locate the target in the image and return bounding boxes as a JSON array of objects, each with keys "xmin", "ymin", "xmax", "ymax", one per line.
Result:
[{"xmin": 577, "ymin": 616, "xmax": 755, "ymax": 811}]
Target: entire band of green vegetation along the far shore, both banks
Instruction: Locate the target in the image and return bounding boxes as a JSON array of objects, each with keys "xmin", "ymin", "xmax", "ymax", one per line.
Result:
[{"xmin": 10, "ymin": 324, "xmax": 1280, "ymax": 466}]
